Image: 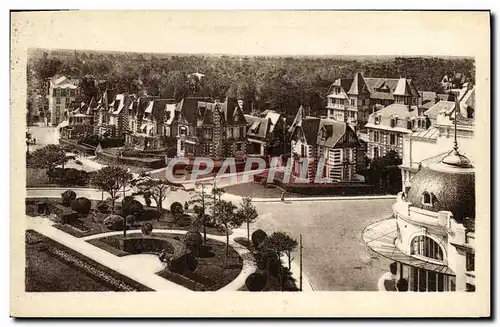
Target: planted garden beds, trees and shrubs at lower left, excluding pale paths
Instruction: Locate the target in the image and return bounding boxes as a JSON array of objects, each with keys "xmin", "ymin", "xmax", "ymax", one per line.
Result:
[{"xmin": 26, "ymin": 145, "xmax": 297, "ymax": 291}]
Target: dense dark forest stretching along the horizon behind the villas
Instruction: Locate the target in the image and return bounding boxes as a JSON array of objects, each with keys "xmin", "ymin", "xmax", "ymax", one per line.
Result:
[{"xmin": 28, "ymin": 50, "xmax": 475, "ymax": 118}]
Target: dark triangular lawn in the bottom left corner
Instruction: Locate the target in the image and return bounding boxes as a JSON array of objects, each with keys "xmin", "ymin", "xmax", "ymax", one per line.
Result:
[{"xmin": 25, "ymin": 230, "xmax": 151, "ymax": 292}]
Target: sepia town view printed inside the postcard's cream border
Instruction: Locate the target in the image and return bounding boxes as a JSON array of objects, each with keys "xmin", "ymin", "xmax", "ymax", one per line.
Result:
[{"xmin": 25, "ymin": 42, "xmax": 477, "ymax": 292}]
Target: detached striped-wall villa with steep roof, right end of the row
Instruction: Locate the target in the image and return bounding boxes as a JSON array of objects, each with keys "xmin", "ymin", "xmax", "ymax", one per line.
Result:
[{"xmin": 289, "ymin": 106, "xmax": 360, "ymax": 182}]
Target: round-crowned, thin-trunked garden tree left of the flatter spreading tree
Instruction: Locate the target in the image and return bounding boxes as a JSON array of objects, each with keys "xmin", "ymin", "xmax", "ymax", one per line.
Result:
[{"xmin": 92, "ymin": 166, "xmax": 132, "ymax": 236}]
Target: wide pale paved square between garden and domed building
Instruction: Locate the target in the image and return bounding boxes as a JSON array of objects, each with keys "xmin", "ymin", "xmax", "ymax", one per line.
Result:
[{"xmin": 251, "ymin": 199, "xmax": 394, "ymax": 291}]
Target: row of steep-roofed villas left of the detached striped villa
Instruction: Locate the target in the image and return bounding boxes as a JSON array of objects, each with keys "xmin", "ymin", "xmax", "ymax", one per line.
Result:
[{"xmin": 59, "ymin": 89, "xmax": 292, "ymax": 157}]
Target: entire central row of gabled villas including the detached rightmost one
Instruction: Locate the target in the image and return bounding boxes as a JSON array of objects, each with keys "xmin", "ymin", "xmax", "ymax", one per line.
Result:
[{"xmin": 59, "ymin": 78, "xmax": 364, "ymax": 182}]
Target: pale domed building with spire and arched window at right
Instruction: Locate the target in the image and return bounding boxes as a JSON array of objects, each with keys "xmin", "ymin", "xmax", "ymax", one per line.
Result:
[{"xmin": 363, "ymin": 119, "xmax": 475, "ymax": 292}]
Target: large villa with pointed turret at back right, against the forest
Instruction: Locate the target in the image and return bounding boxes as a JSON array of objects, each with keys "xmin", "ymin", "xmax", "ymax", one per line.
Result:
[{"xmin": 326, "ymin": 72, "xmax": 421, "ymax": 129}]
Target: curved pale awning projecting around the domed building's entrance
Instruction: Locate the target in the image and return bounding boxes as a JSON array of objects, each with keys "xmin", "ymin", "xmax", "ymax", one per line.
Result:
[{"xmin": 362, "ymin": 218, "xmax": 455, "ymax": 275}]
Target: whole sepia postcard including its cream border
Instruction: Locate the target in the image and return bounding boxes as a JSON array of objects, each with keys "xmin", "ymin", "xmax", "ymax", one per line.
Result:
[{"xmin": 10, "ymin": 11, "xmax": 491, "ymax": 318}]
